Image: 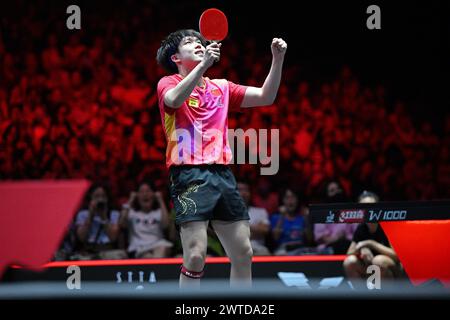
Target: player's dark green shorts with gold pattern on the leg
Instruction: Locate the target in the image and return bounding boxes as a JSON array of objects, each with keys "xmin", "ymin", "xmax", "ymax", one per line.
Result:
[{"xmin": 169, "ymin": 164, "xmax": 250, "ymax": 225}]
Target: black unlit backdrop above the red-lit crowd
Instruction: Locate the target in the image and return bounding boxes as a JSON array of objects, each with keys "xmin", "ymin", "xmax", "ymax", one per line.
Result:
[{"xmin": 0, "ymin": 0, "xmax": 450, "ymax": 117}]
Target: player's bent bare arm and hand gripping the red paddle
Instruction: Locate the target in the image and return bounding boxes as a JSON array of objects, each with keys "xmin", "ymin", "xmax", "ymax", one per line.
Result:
[{"xmin": 164, "ymin": 43, "xmax": 220, "ymax": 109}]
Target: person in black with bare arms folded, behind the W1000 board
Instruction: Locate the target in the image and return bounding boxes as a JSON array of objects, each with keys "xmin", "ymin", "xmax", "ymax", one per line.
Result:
[{"xmin": 344, "ymin": 191, "xmax": 401, "ymax": 288}]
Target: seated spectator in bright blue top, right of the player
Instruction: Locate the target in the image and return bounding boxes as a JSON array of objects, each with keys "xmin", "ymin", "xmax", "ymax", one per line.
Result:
[{"xmin": 270, "ymin": 189, "xmax": 312, "ymax": 255}]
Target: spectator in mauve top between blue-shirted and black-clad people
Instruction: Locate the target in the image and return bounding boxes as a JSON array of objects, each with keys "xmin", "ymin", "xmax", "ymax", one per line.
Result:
[{"xmin": 314, "ymin": 180, "xmax": 358, "ymax": 254}]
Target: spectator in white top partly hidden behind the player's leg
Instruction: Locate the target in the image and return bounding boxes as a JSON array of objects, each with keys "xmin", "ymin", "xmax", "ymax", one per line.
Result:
[{"xmin": 237, "ymin": 182, "xmax": 270, "ymax": 256}]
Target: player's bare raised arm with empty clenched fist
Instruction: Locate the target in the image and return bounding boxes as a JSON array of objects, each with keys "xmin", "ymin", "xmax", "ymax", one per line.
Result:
[{"xmin": 241, "ymin": 38, "xmax": 287, "ymax": 108}]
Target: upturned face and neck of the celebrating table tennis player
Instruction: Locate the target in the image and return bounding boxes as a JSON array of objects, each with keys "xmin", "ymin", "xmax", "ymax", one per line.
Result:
[{"xmin": 172, "ymin": 36, "xmax": 205, "ymax": 68}]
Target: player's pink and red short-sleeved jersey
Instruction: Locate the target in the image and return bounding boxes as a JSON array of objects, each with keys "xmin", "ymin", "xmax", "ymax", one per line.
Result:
[{"xmin": 158, "ymin": 74, "xmax": 247, "ymax": 168}]
